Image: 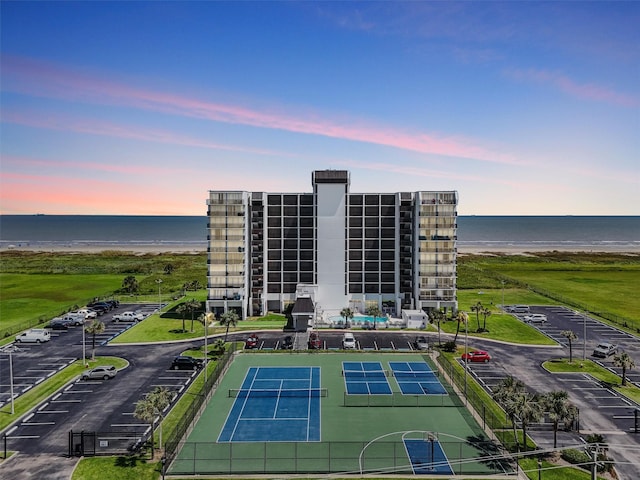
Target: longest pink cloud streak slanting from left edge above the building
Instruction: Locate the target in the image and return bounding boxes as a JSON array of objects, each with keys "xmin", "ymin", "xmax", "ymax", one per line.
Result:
[{"xmin": 3, "ymin": 56, "xmax": 521, "ymax": 164}]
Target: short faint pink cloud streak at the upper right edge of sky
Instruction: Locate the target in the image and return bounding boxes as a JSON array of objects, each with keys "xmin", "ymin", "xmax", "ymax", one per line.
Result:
[{"xmin": 505, "ymin": 69, "xmax": 640, "ymax": 108}]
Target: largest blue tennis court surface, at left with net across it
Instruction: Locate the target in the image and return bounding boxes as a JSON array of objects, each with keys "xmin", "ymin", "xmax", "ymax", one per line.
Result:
[{"xmin": 218, "ymin": 367, "xmax": 322, "ymax": 442}]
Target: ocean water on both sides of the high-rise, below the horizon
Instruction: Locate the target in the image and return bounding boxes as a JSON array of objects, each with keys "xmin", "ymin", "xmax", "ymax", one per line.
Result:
[{"xmin": 0, "ymin": 215, "xmax": 640, "ymax": 250}]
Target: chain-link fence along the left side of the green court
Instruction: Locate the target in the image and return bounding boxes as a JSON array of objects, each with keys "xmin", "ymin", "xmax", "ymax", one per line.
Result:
[{"xmin": 164, "ymin": 342, "xmax": 242, "ymax": 463}]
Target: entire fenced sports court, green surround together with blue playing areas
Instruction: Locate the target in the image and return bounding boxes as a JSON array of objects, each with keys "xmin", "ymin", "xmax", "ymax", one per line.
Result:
[{"xmin": 167, "ymin": 352, "xmax": 508, "ymax": 476}]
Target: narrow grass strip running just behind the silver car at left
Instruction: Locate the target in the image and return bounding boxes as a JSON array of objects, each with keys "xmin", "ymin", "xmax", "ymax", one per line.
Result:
[{"xmin": 0, "ymin": 357, "xmax": 129, "ymax": 430}]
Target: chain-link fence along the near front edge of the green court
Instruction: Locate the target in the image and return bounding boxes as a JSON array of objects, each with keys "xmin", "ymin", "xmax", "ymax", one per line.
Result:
[{"xmin": 169, "ymin": 438, "xmax": 515, "ymax": 478}]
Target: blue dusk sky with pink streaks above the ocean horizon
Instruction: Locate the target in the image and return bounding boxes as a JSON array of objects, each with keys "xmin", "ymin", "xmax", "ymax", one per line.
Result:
[{"xmin": 0, "ymin": 0, "xmax": 640, "ymax": 215}]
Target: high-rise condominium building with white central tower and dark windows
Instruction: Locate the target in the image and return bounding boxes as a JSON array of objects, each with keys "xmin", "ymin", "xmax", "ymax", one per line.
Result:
[{"xmin": 207, "ymin": 170, "xmax": 458, "ymax": 326}]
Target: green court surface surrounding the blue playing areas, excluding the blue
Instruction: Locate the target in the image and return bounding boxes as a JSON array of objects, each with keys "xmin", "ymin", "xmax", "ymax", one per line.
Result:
[{"xmin": 168, "ymin": 352, "xmax": 511, "ymax": 475}]
